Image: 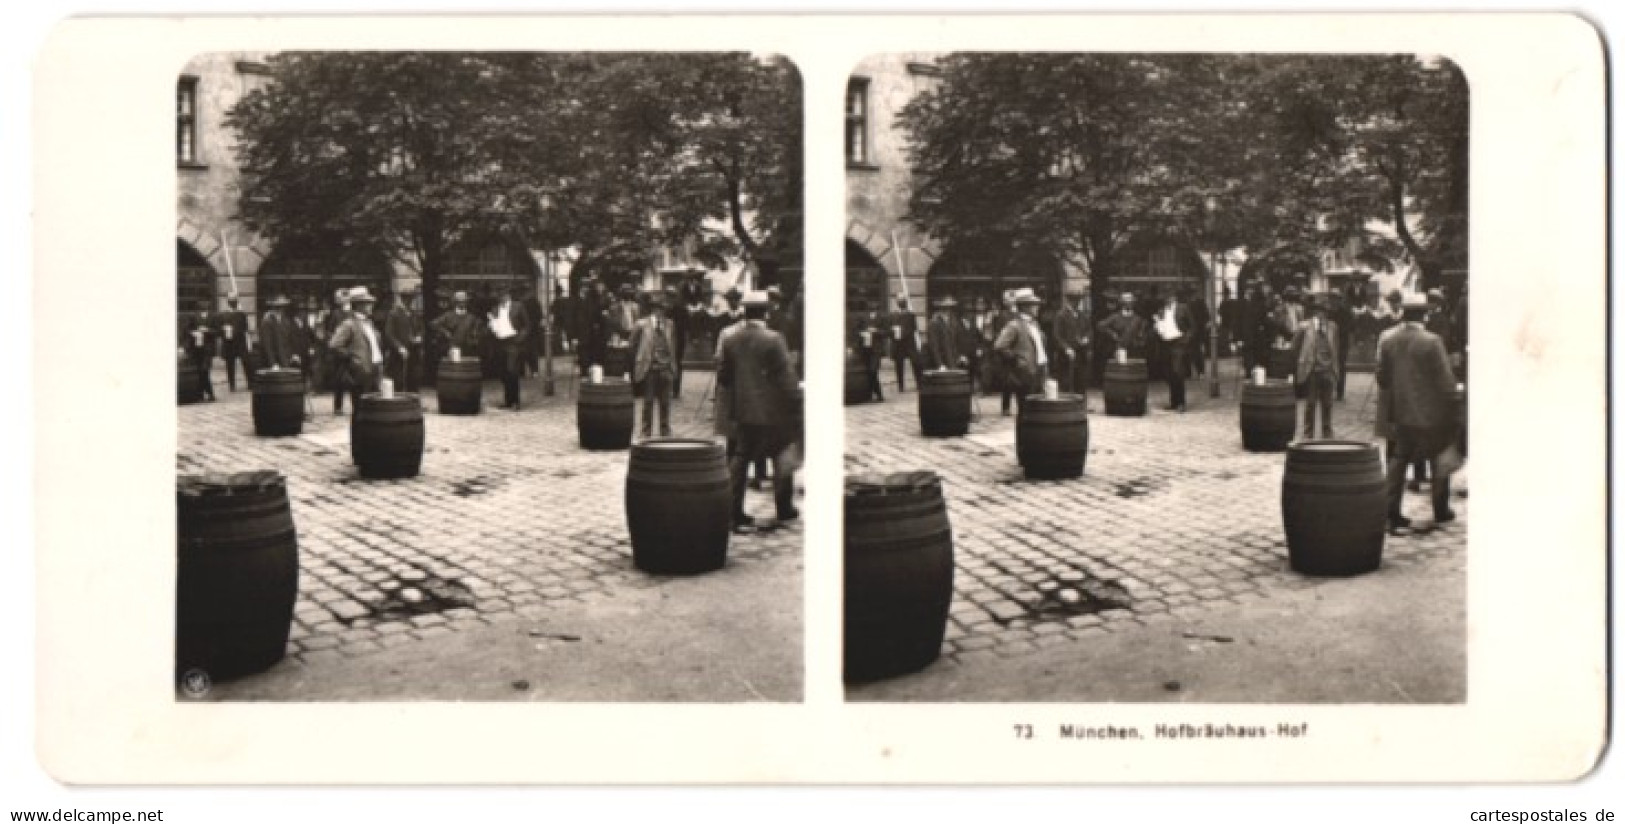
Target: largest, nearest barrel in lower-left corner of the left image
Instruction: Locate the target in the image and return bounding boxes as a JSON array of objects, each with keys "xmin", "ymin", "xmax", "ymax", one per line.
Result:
[{"xmin": 176, "ymin": 471, "xmax": 299, "ymax": 681}]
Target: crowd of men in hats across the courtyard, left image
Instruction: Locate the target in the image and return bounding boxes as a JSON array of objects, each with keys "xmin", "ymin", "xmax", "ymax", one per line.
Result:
[{"xmin": 177, "ymin": 278, "xmax": 803, "ymax": 531}]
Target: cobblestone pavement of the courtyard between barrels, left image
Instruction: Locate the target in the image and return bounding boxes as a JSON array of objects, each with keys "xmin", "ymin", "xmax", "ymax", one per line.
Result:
[{"xmin": 176, "ymin": 361, "xmax": 801, "ymax": 676}]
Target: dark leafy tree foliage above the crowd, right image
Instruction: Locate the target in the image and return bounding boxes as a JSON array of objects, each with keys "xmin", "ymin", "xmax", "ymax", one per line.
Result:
[{"xmin": 900, "ymin": 54, "xmax": 1467, "ymax": 289}]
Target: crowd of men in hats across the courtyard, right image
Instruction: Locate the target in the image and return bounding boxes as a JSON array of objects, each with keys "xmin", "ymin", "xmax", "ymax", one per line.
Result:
[{"xmin": 848, "ymin": 283, "xmax": 1467, "ymax": 530}]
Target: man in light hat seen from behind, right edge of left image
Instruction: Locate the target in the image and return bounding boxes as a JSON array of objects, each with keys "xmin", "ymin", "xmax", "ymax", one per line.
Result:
[{"xmin": 717, "ymin": 293, "xmax": 800, "ymax": 531}]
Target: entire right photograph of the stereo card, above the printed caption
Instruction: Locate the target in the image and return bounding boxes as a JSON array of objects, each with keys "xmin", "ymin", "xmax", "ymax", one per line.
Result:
[{"xmin": 827, "ymin": 52, "xmax": 1471, "ymax": 704}]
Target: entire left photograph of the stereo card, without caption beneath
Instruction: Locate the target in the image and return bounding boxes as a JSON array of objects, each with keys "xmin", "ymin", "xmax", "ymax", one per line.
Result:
[{"xmin": 174, "ymin": 52, "xmax": 804, "ymax": 702}]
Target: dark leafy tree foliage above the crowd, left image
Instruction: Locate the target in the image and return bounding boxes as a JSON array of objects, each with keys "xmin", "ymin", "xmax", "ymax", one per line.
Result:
[{"xmin": 228, "ymin": 52, "xmax": 801, "ymax": 312}]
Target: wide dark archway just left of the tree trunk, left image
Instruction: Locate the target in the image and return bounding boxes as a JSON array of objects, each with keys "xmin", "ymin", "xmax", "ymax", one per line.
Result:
[{"xmin": 257, "ymin": 237, "xmax": 393, "ymax": 310}]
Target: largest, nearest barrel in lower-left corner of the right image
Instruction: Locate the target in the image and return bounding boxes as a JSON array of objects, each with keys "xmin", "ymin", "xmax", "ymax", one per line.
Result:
[{"xmin": 843, "ymin": 471, "xmax": 954, "ymax": 681}]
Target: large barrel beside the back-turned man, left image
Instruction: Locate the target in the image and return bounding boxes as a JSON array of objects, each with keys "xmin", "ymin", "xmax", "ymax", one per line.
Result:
[{"xmin": 626, "ymin": 439, "xmax": 733, "ymax": 575}]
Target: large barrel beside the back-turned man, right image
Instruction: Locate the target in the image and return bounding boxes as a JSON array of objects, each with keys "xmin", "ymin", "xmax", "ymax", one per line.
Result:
[{"xmin": 1281, "ymin": 440, "xmax": 1388, "ymax": 575}]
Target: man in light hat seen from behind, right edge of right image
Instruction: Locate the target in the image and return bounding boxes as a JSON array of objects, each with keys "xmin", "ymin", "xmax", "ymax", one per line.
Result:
[{"xmin": 1376, "ymin": 296, "xmax": 1456, "ymax": 530}]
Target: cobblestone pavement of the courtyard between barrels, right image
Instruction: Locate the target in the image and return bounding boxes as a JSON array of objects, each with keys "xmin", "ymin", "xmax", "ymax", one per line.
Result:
[{"xmin": 845, "ymin": 361, "xmax": 1467, "ymax": 663}]
